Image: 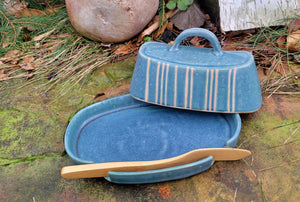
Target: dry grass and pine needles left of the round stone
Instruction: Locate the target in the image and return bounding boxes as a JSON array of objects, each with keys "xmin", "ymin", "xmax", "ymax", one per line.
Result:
[{"xmin": 0, "ymin": 5, "xmax": 117, "ymax": 93}]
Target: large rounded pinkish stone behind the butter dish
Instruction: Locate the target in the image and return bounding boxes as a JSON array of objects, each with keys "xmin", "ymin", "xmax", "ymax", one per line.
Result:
[{"xmin": 66, "ymin": 0, "xmax": 159, "ymax": 43}]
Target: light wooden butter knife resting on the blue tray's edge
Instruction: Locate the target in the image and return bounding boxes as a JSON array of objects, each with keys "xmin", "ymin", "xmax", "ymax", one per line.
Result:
[{"xmin": 61, "ymin": 148, "xmax": 251, "ymax": 179}]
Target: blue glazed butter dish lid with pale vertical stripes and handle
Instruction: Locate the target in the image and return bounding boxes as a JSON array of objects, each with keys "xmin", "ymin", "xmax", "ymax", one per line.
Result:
[{"xmin": 130, "ymin": 28, "xmax": 262, "ymax": 113}]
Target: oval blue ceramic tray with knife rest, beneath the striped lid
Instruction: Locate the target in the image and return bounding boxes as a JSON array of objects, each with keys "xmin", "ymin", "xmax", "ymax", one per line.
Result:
[{"xmin": 65, "ymin": 94, "xmax": 241, "ymax": 184}]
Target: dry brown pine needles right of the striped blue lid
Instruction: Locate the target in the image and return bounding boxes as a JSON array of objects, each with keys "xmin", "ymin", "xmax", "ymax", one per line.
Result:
[{"xmin": 243, "ymin": 16, "xmax": 300, "ymax": 97}]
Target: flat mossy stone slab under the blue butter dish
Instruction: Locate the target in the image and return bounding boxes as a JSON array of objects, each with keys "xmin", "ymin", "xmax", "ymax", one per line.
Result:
[{"xmin": 0, "ymin": 59, "xmax": 300, "ymax": 201}]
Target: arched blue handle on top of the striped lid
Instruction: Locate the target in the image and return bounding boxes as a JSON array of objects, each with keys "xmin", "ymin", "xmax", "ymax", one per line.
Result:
[{"xmin": 170, "ymin": 28, "xmax": 223, "ymax": 56}]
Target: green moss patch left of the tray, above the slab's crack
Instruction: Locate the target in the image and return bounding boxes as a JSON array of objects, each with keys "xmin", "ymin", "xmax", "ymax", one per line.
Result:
[{"xmin": 0, "ymin": 108, "xmax": 64, "ymax": 158}]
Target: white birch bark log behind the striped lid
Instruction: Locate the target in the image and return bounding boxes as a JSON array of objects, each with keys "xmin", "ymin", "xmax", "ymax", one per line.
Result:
[{"xmin": 199, "ymin": 0, "xmax": 300, "ymax": 32}]
